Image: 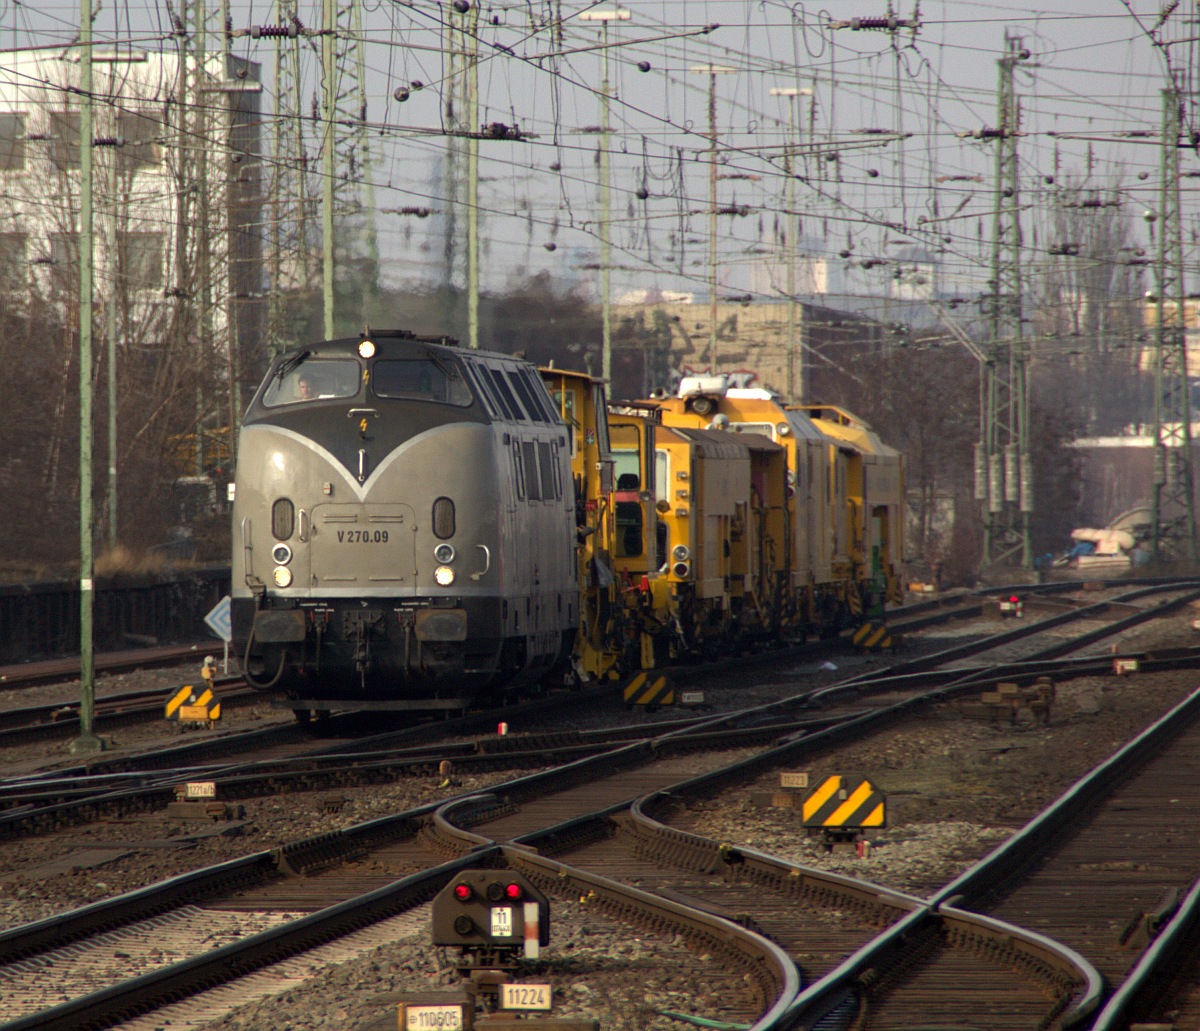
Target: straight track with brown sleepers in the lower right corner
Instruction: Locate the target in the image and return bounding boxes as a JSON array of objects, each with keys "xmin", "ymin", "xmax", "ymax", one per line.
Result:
[{"xmin": 777, "ymin": 691, "xmax": 1200, "ymax": 1029}]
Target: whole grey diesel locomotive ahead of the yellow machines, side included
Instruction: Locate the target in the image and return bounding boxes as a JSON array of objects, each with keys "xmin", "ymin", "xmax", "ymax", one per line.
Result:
[{"xmin": 232, "ymin": 331, "xmax": 580, "ymax": 713}]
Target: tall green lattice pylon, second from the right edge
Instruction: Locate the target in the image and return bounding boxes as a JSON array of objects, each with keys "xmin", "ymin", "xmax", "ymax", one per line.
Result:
[{"xmin": 976, "ymin": 34, "xmax": 1033, "ymax": 569}]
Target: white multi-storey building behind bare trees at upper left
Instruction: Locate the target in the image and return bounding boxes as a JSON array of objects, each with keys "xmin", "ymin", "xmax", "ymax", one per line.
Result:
[{"xmin": 0, "ymin": 48, "xmax": 263, "ymax": 367}]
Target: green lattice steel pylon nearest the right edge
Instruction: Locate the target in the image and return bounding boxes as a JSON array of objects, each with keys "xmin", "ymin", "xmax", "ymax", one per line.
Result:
[{"xmin": 1152, "ymin": 89, "xmax": 1196, "ymax": 562}]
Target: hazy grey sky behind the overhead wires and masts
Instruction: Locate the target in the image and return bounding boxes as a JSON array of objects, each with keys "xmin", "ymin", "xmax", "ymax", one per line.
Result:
[{"xmin": 0, "ymin": 0, "xmax": 1200, "ymax": 314}]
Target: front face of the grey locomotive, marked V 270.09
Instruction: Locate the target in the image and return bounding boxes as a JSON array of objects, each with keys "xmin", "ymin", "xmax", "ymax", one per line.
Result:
[{"xmin": 232, "ymin": 335, "xmax": 532, "ymax": 712}]
